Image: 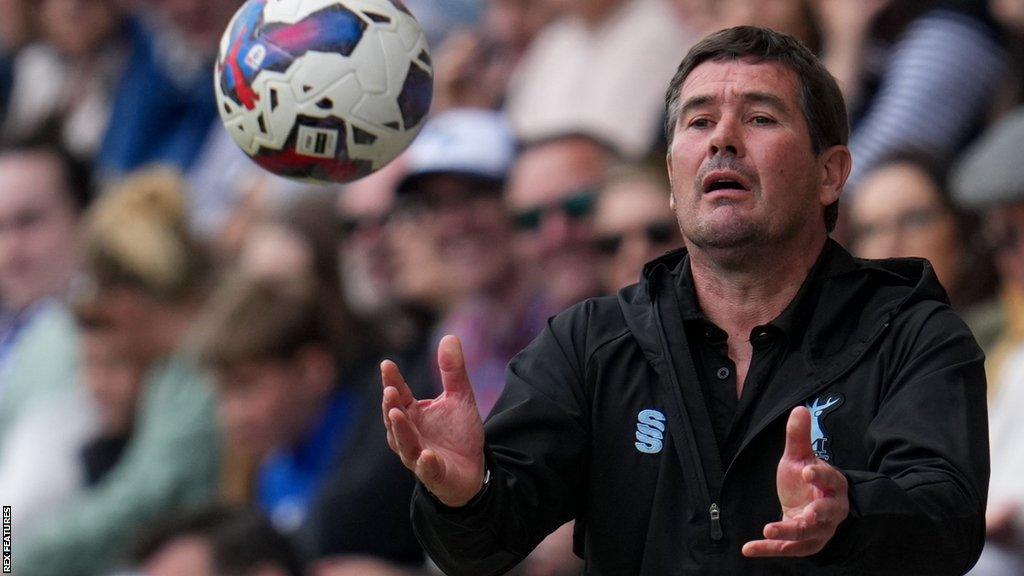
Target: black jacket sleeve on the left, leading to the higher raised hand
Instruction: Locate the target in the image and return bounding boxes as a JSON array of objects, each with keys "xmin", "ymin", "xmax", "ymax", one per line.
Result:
[{"xmin": 413, "ymin": 306, "xmax": 589, "ymax": 576}]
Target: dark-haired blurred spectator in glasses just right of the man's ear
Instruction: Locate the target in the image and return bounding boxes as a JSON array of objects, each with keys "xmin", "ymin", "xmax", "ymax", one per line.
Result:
[{"xmin": 849, "ymin": 154, "xmax": 995, "ymax": 312}]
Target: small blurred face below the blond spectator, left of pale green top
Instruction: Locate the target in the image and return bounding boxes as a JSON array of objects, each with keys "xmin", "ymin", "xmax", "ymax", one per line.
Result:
[{"xmin": 81, "ymin": 328, "xmax": 143, "ymax": 435}]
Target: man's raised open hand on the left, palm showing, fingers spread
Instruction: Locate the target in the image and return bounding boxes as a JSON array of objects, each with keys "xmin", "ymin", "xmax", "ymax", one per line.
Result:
[{"xmin": 381, "ymin": 336, "xmax": 483, "ymax": 507}]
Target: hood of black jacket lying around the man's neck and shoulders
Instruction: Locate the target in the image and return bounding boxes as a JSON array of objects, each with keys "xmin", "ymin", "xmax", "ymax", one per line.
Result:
[{"xmin": 618, "ymin": 239, "xmax": 949, "ymax": 380}]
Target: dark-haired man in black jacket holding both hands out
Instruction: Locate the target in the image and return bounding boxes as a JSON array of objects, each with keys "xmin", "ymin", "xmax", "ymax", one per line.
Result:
[{"xmin": 382, "ymin": 27, "xmax": 988, "ymax": 576}]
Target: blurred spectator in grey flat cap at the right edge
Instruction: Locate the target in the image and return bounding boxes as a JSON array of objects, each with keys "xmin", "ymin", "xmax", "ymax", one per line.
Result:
[{"xmin": 952, "ymin": 109, "xmax": 1024, "ymax": 576}]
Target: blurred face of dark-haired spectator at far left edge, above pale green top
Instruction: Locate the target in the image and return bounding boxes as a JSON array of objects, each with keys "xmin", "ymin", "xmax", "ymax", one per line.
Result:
[{"xmin": 0, "ymin": 154, "xmax": 78, "ymax": 311}]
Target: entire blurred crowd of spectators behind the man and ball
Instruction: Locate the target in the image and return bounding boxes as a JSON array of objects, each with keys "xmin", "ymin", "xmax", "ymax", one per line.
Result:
[{"xmin": 0, "ymin": 0, "xmax": 1024, "ymax": 576}]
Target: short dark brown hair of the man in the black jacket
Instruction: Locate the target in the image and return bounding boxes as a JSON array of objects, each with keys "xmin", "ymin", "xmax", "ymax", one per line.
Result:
[{"xmin": 665, "ymin": 26, "xmax": 850, "ymax": 232}]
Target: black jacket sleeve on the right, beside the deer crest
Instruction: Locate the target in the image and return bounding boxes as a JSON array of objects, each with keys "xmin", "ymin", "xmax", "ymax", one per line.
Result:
[{"xmin": 817, "ymin": 307, "xmax": 989, "ymax": 575}]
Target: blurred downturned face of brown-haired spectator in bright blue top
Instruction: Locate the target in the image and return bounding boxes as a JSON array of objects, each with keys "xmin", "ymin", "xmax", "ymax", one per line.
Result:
[{"xmin": 214, "ymin": 345, "xmax": 335, "ymax": 458}]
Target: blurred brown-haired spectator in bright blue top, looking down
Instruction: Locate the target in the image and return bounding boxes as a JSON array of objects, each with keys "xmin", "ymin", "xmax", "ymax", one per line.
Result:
[{"xmin": 198, "ymin": 275, "xmax": 424, "ymax": 566}]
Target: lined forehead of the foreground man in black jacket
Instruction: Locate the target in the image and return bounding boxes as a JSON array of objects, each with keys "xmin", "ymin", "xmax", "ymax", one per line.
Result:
[{"xmin": 680, "ymin": 58, "xmax": 800, "ymax": 102}]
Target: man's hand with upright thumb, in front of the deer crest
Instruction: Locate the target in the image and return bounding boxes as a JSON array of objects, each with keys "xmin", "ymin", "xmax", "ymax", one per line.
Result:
[{"xmin": 743, "ymin": 407, "xmax": 850, "ymax": 558}]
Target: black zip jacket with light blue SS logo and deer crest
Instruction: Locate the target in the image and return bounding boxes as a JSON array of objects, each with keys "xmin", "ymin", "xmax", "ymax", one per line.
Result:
[{"xmin": 413, "ymin": 241, "xmax": 988, "ymax": 576}]
